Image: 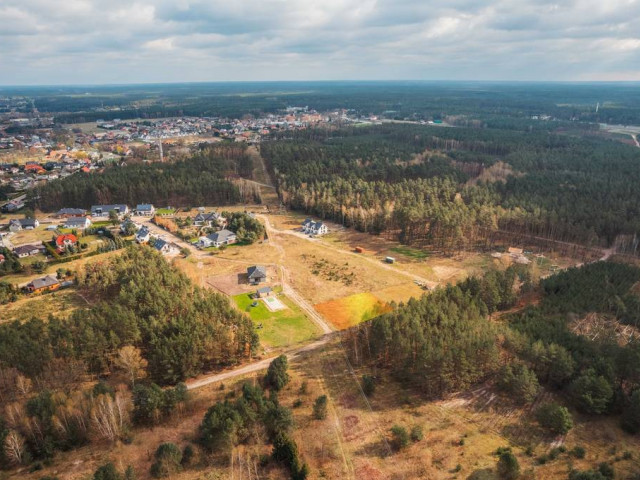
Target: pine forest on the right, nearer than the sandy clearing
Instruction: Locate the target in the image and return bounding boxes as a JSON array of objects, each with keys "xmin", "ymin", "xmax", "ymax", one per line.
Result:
[{"xmin": 344, "ymin": 262, "xmax": 640, "ymax": 433}]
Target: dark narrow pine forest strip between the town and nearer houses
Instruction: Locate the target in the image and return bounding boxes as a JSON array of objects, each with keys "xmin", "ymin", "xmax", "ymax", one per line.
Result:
[{"xmin": 27, "ymin": 144, "xmax": 260, "ymax": 211}]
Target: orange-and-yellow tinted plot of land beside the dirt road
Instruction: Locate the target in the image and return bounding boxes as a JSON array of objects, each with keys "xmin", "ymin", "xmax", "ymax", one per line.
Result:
[{"xmin": 314, "ymin": 293, "xmax": 391, "ymax": 330}]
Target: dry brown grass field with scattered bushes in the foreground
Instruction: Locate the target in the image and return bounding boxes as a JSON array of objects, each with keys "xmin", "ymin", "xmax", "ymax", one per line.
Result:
[{"xmin": 20, "ymin": 342, "xmax": 640, "ymax": 480}]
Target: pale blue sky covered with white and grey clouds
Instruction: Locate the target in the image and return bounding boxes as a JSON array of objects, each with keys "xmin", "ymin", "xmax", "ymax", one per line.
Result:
[{"xmin": 0, "ymin": 0, "xmax": 640, "ymax": 85}]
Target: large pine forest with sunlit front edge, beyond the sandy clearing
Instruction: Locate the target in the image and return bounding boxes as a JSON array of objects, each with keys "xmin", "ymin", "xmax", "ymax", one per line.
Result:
[{"xmin": 261, "ymin": 124, "xmax": 640, "ymax": 253}]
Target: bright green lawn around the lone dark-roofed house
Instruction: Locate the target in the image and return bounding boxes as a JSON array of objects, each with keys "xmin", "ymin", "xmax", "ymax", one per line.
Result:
[{"xmin": 233, "ymin": 293, "xmax": 320, "ymax": 348}]
